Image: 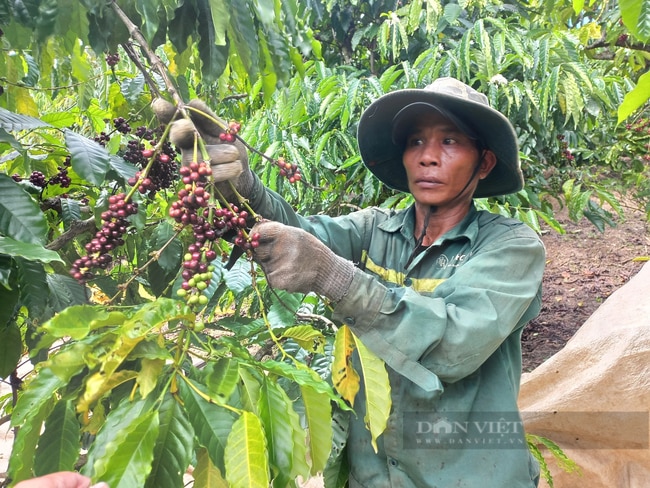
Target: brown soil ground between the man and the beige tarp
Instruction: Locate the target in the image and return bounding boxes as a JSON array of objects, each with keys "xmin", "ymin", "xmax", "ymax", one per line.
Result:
[{"xmin": 522, "ymin": 201, "xmax": 650, "ymax": 372}]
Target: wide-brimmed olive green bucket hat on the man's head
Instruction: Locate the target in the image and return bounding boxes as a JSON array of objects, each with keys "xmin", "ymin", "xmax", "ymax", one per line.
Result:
[{"xmin": 357, "ymin": 78, "xmax": 524, "ymax": 198}]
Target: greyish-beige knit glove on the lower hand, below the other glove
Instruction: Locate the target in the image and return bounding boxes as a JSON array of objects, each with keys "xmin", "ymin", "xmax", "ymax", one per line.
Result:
[{"xmin": 251, "ymin": 221, "xmax": 355, "ymax": 302}]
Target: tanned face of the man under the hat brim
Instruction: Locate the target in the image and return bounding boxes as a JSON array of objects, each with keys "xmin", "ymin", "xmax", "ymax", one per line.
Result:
[{"xmin": 402, "ymin": 111, "xmax": 496, "ymax": 210}]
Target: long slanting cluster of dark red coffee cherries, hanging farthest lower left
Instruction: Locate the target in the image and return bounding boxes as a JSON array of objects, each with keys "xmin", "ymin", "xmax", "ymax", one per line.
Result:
[{"xmin": 70, "ymin": 193, "xmax": 138, "ymax": 283}]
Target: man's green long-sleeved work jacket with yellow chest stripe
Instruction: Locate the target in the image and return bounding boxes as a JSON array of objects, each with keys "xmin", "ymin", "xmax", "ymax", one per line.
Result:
[{"xmin": 251, "ymin": 182, "xmax": 545, "ymax": 488}]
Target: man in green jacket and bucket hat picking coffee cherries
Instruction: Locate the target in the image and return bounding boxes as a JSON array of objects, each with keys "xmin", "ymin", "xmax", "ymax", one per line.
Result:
[{"xmin": 157, "ymin": 78, "xmax": 545, "ymax": 488}]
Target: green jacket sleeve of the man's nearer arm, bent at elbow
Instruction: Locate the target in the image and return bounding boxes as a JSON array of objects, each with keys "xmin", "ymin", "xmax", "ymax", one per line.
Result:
[{"xmin": 334, "ymin": 225, "xmax": 545, "ymax": 391}]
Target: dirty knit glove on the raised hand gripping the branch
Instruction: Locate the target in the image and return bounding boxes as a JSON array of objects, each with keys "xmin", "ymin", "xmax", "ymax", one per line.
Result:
[{"xmin": 152, "ymin": 98, "xmax": 254, "ymax": 202}]
